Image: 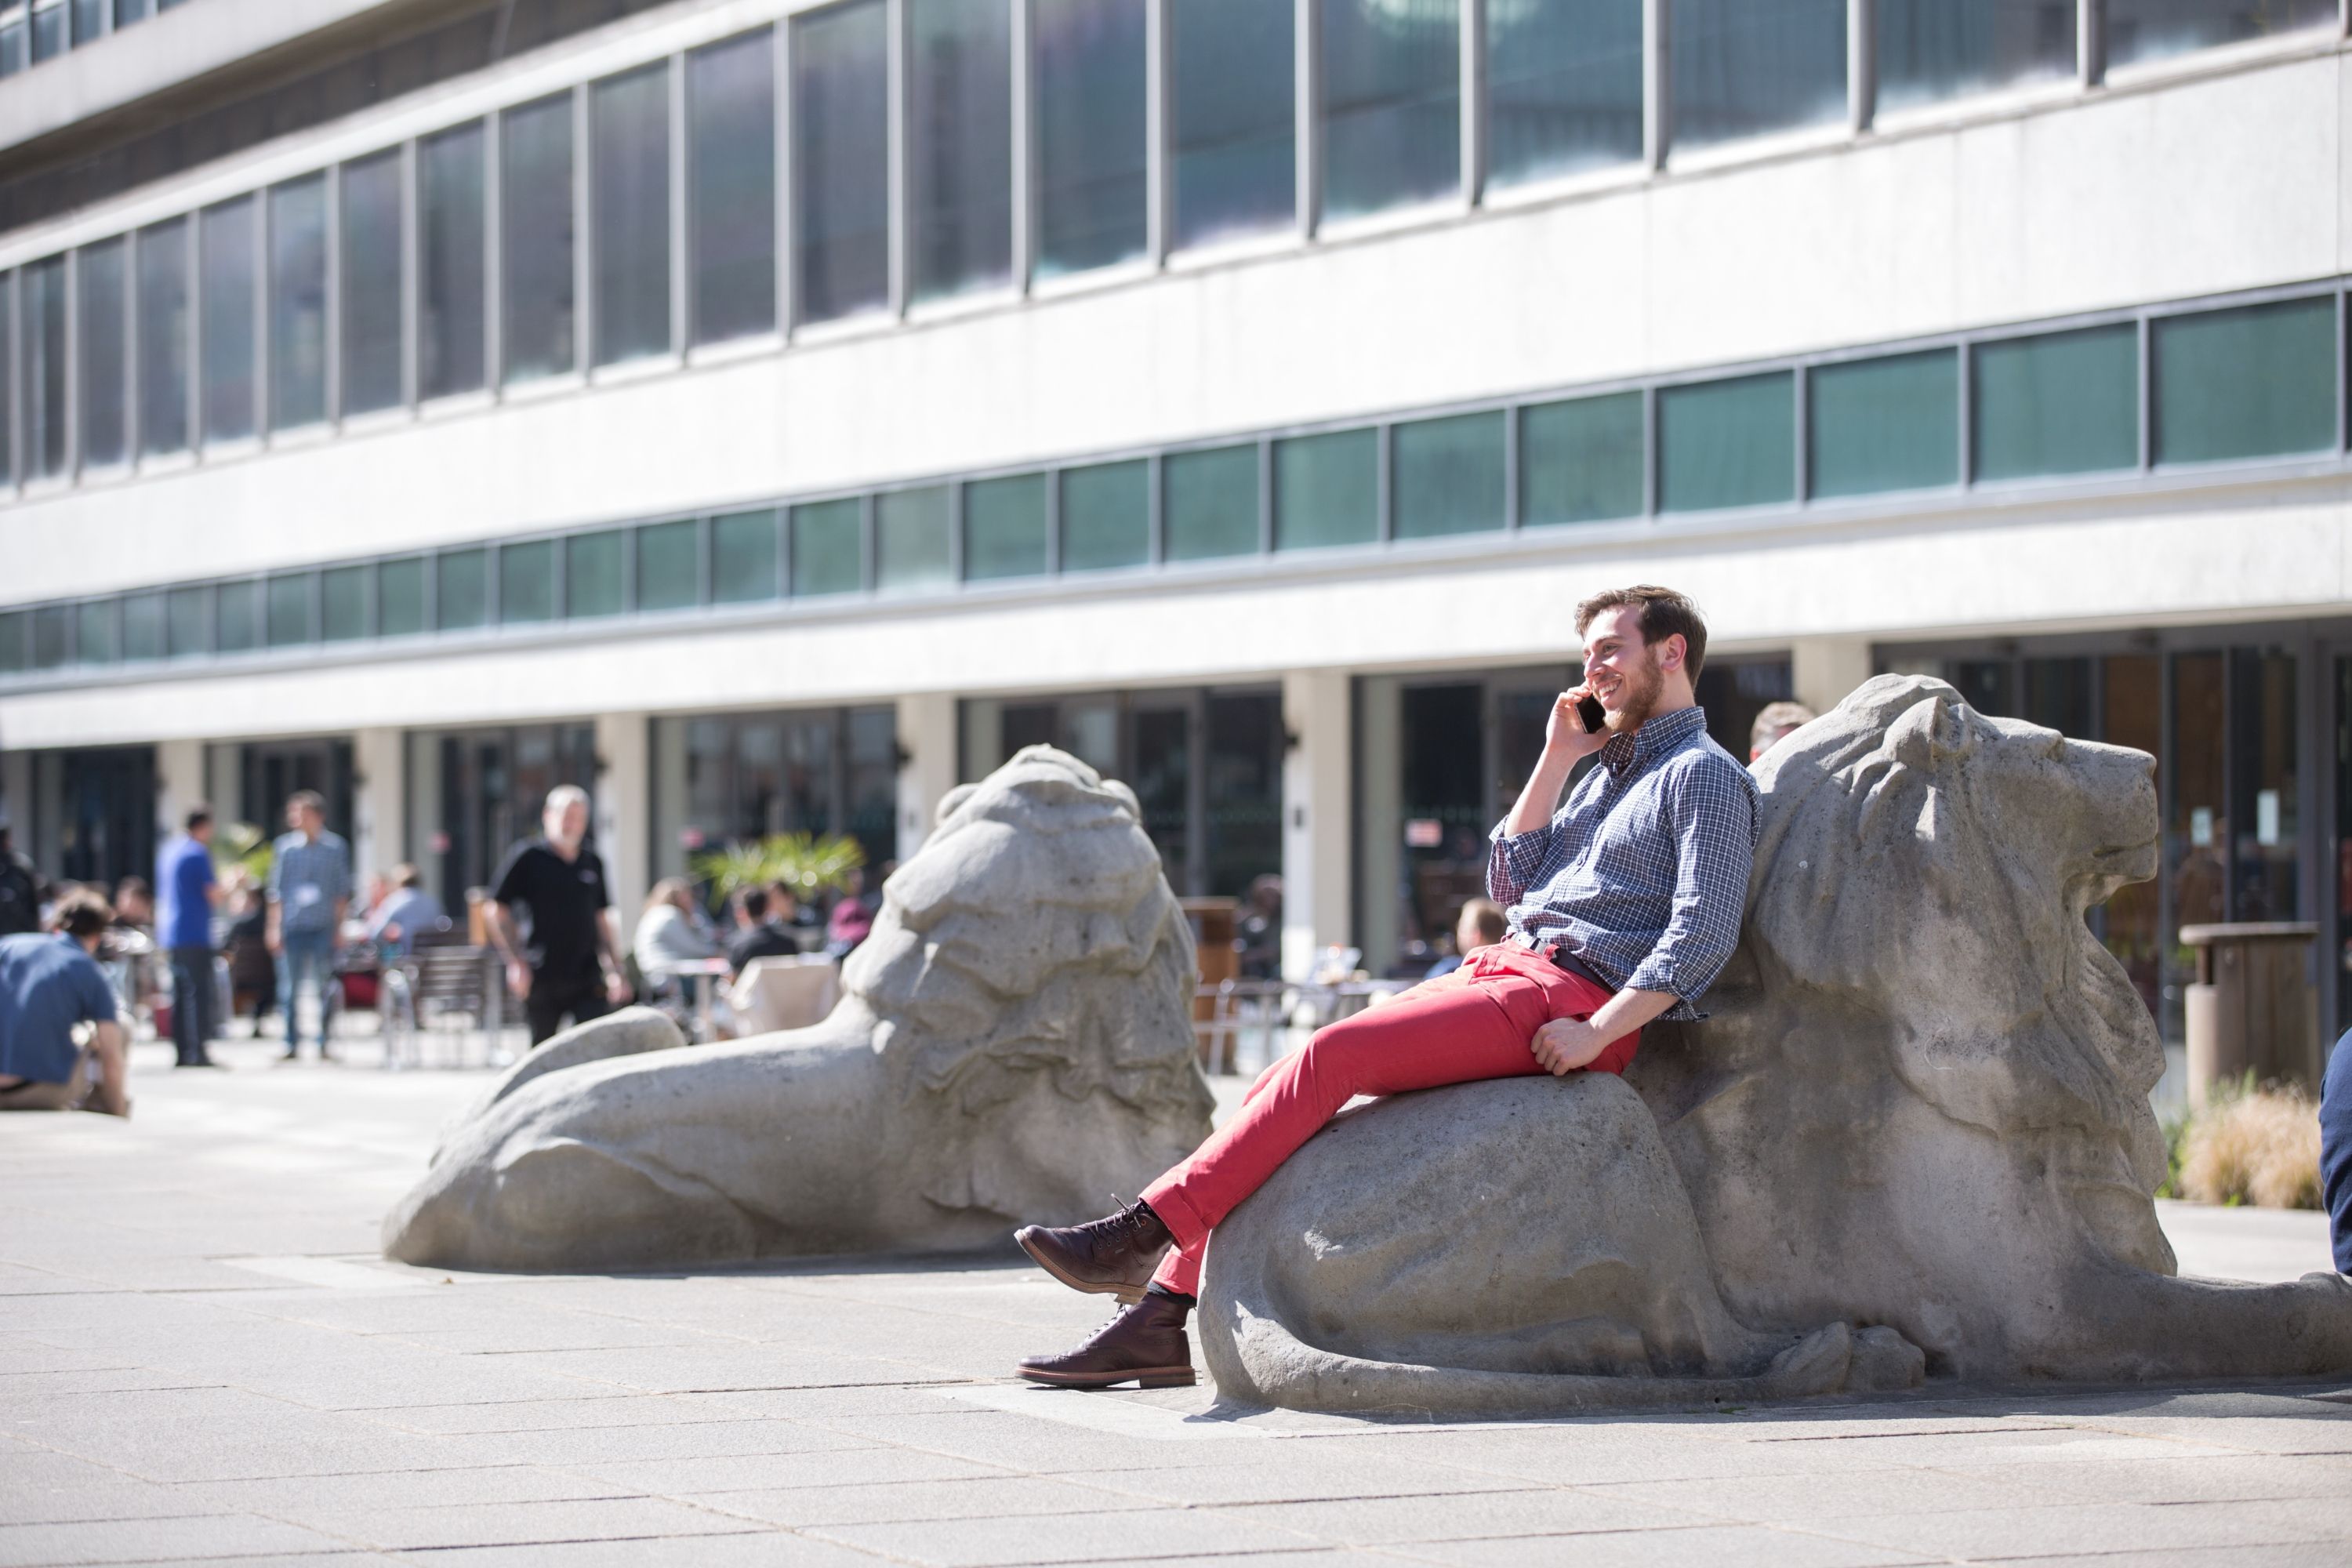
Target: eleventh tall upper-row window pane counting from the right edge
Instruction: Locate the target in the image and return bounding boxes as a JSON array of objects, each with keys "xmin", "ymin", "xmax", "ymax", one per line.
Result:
[{"xmin": 588, "ymin": 64, "xmax": 670, "ymax": 365}]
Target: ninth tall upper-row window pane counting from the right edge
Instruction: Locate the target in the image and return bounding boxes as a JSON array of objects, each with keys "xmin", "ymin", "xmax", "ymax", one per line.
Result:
[{"xmin": 793, "ymin": 0, "xmax": 889, "ymax": 322}]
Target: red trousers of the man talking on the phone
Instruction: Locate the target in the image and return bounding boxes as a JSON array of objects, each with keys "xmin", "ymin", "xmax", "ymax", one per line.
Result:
[{"xmin": 1143, "ymin": 942, "xmax": 1642, "ymax": 1295}]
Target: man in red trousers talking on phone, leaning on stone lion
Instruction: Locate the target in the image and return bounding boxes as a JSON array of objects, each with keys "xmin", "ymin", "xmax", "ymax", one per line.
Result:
[{"xmin": 1016, "ymin": 586, "xmax": 1759, "ymax": 1387}]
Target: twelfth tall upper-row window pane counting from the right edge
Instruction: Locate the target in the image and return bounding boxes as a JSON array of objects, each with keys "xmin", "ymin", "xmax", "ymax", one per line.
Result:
[{"xmin": 499, "ymin": 92, "xmax": 576, "ymax": 381}]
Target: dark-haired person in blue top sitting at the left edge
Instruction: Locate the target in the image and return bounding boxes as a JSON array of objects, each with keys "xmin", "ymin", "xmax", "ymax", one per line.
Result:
[{"xmin": 0, "ymin": 888, "xmax": 132, "ymax": 1116}]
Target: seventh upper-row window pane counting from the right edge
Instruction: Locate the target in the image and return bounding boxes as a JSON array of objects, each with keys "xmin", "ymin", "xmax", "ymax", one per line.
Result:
[{"xmin": 1030, "ymin": 0, "xmax": 1145, "ymax": 278}]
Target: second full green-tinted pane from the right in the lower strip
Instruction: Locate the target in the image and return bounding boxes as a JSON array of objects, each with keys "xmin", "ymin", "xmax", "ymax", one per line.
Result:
[{"xmin": 1969, "ymin": 322, "xmax": 2140, "ymax": 480}]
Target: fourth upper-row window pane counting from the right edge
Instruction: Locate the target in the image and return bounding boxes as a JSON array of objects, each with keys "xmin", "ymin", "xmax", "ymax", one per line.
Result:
[{"xmin": 1486, "ymin": 0, "xmax": 1642, "ymax": 186}]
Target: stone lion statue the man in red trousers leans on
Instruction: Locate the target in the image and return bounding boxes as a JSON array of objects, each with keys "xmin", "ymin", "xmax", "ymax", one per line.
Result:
[{"xmin": 1200, "ymin": 675, "xmax": 2352, "ymax": 1413}]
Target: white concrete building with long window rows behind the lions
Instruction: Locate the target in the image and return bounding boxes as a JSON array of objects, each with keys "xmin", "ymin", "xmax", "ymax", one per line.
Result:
[{"xmin": 0, "ymin": 0, "xmax": 2352, "ymax": 1053}]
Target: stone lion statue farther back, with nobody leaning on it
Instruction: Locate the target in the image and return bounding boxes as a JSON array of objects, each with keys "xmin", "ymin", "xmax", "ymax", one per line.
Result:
[{"xmin": 383, "ymin": 746, "xmax": 1211, "ymax": 1269}]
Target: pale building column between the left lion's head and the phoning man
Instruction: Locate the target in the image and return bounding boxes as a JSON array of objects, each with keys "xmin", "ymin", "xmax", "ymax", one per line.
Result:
[{"xmin": 1282, "ymin": 670, "xmax": 1355, "ymax": 980}]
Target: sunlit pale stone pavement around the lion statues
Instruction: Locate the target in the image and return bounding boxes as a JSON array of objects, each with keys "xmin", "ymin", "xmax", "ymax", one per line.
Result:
[{"xmin": 0, "ymin": 1044, "xmax": 2352, "ymax": 1568}]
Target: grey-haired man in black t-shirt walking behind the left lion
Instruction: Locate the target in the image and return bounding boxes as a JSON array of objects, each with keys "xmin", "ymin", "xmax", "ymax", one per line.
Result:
[{"xmin": 489, "ymin": 785, "xmax": 628, "ymax": 1046}]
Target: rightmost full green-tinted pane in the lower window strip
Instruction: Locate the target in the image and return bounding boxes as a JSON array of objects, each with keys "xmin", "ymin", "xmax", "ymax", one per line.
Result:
[{"xmin": 2150, "ymin": 299, "xmax": 2336, "ymax": 463}]
